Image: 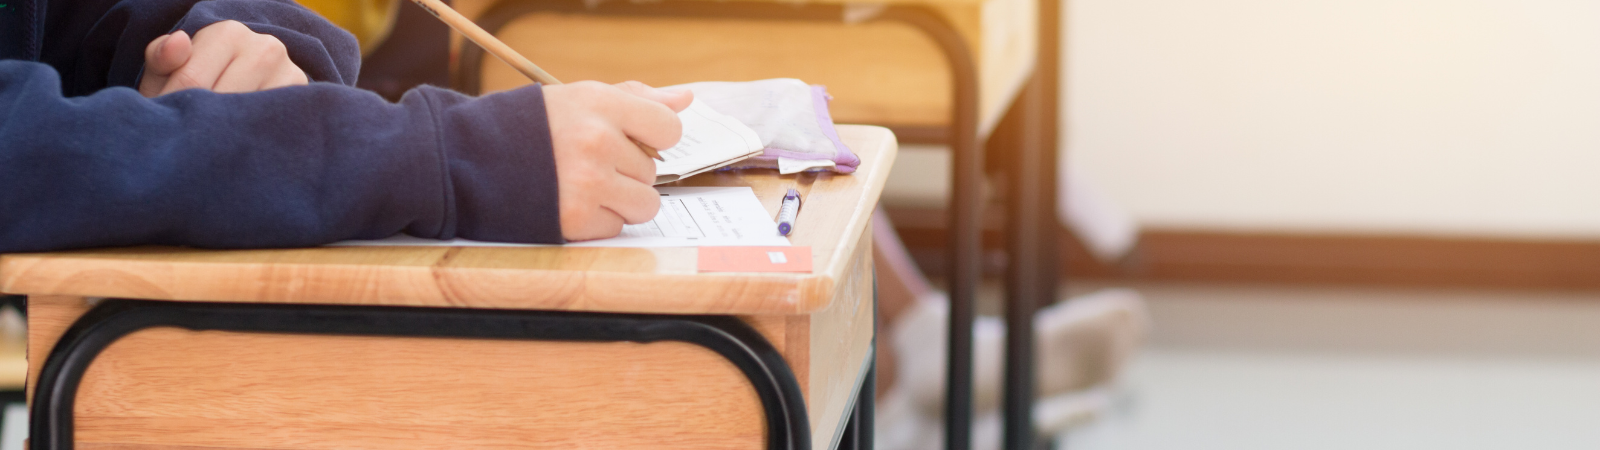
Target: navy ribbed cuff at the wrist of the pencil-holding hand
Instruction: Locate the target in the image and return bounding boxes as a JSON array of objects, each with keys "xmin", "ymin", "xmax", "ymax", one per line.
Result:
[{"xmin": 422, "ymin": 85, "xmax": 565, "ymax": 243}]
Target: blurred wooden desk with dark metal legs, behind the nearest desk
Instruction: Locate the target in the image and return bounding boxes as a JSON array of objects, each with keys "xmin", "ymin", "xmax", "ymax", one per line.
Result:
[{"xmin": 453, "ymin": 0, "xmax": 1061, "ymax": 450}]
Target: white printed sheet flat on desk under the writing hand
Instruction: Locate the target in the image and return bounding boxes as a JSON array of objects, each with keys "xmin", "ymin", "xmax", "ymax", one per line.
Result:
[{"xmin": 331, "ymin": 186, "xmax": 789, "ymax": 247}]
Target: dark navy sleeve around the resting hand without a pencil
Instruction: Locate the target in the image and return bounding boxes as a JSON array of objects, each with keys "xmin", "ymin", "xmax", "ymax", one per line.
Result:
[{"xmin": 38, "ymin": 0, "xmax": 362, "ymax": 96}]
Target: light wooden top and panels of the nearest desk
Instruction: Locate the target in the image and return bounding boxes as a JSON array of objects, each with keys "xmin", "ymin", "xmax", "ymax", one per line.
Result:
[{"xmin": 0, "ymin": 127, "xmax": 896, "ymax": 448}]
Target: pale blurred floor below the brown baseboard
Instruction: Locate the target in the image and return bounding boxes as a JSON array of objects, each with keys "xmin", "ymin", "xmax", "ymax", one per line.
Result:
[{"xmin": 1062, "ymin": 285, "xmax": 1600, "ymax": 450}]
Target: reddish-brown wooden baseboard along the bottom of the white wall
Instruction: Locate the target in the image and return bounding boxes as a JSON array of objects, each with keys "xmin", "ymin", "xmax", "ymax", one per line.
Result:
[{"xmin": 890, "ymin": 210, "xmax": 1600, "ymax": 290}]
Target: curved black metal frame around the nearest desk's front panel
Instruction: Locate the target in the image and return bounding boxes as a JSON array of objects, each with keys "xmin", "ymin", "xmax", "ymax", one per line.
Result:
[{"xmin": 29, "ymin": 295, "xmax": 877, "ymax": 450}]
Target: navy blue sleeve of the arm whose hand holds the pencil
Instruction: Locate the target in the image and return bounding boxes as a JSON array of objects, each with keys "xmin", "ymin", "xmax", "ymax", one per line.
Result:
[{"xmin": 0, "ymin": 61, "xmax": 562, "ymax": 253}]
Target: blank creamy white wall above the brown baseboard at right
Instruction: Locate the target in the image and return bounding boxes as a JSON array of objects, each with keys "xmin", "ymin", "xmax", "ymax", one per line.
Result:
[{"xmin": 1064, "ymin": 0, "xmax": 1600, "ymax": 239}]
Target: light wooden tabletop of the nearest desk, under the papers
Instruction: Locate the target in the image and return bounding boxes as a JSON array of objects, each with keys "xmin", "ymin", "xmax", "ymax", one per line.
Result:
[{"xmin": 0, "ymin": 125, "xmax": 896, "ymax": 314}]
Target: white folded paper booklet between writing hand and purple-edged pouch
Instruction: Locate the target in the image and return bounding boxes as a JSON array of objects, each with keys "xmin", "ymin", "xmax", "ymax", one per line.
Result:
[{"xmin": 656, "ymin": 99, "xmax": 765, "ymax": 184}]
